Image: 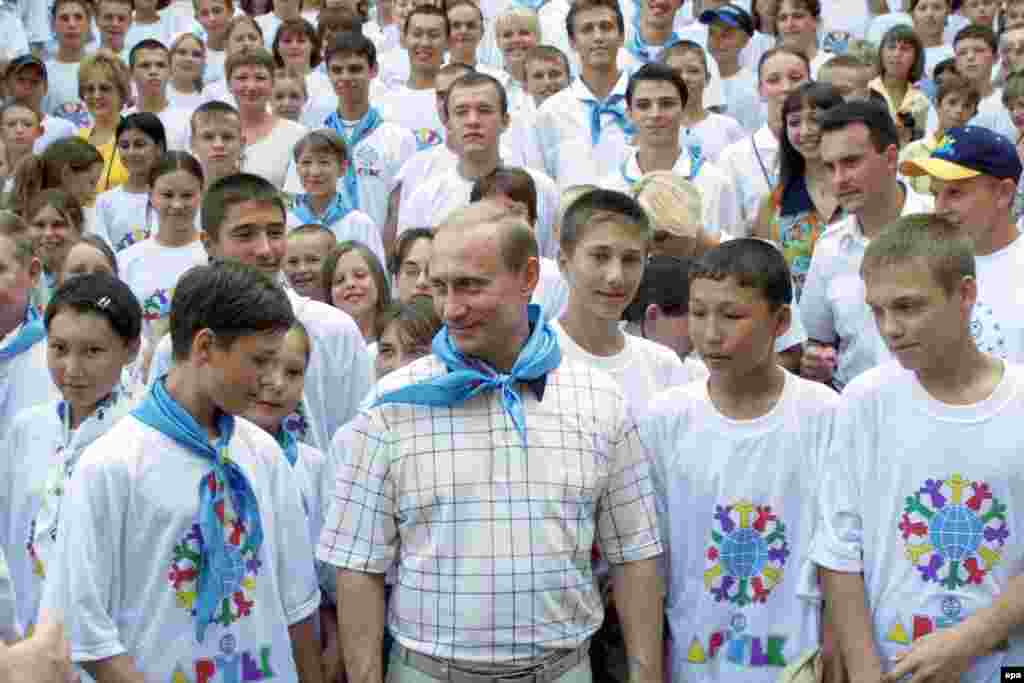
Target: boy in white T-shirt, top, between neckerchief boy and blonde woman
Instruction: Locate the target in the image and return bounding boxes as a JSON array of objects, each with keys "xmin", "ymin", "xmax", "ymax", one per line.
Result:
[{"xmin": 374, "ymin": 5, "xmax": 449, "ymax": 151}]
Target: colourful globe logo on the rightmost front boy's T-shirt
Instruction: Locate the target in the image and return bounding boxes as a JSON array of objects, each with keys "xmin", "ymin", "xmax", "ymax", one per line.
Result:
[{"xmin": 898, "ymin": 474, "xmax": 1010, "ymax": 590}]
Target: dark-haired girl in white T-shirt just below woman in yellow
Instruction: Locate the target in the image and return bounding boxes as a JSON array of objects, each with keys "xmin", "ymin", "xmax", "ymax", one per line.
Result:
[{"xmin": 96, "ymin": 113, "xmax": 167, "ymax": 252}]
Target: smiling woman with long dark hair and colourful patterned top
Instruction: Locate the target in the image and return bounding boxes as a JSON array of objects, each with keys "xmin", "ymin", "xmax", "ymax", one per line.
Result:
[{"xmin": 753, "ymin": 83, "xmax": 843, "ymax": 297}]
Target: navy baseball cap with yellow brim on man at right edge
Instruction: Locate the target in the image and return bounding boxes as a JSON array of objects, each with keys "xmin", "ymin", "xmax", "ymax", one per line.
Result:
[{"xmin": 900, "ymin": 126, "xmax": 1021, "ymax": 182}]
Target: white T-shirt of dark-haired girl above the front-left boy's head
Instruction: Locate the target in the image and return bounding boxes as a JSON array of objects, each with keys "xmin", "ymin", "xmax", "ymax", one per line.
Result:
[{"xmin": 118, "ymin": 238, "xmax": 208, "ymax": 336}]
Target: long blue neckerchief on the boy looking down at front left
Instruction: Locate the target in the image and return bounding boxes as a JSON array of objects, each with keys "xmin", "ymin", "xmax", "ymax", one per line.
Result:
[{"xmin": 131, "ymin": 378, "xmax": 263, "ymax": 642}]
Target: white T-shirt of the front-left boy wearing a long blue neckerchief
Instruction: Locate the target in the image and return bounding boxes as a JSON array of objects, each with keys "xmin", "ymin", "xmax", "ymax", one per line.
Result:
[{"xmin": 43, "ymin": 417, "xmax": 319, "ymax": 683}]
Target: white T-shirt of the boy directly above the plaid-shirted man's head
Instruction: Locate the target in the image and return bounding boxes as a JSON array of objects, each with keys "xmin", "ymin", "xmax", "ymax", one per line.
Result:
[{"xmin": 398, "ymin": 165, "xmax": 559, "ymax": 258}]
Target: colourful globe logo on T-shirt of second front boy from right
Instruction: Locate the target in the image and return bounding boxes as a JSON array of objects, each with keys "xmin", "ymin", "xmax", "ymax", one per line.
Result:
[{"xmin": 705, "ymin": 501, "xmax": 791, "ymax": 607}]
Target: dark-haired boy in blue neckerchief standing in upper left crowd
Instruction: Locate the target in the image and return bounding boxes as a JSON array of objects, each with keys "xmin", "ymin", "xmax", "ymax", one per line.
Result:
[{"xmin": 285, "ymin": 33, "xmax": 416, "ymax": 233}]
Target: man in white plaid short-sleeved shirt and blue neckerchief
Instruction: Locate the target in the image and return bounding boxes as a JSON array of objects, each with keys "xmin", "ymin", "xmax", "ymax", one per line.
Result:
[{"xmin": 317, "ymin": 197, "xmax": 663, "ymax": 683}]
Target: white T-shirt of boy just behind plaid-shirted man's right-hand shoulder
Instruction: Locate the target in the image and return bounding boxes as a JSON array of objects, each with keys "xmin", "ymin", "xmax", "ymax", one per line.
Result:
[{"xmin": 551, "ymin": 319, "xmax": 689, "ymax": 417}]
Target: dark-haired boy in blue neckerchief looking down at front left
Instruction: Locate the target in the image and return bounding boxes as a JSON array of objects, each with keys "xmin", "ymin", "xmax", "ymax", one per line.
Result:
[{"xmin": 43, "ymin": 263, "xmax": 322, "ymax": 683}]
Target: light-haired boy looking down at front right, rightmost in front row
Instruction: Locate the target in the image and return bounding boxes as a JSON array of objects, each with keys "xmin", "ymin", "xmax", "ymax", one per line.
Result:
[{"xmin": 810, "ymin": 215, "xmax": 1024, "ymax": 683}]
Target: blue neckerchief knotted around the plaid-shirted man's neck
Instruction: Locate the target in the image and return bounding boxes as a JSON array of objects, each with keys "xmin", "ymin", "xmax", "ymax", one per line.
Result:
[{"xmin": 374, "ymin": 304, "xmax": 562, "ymax": 445}]
